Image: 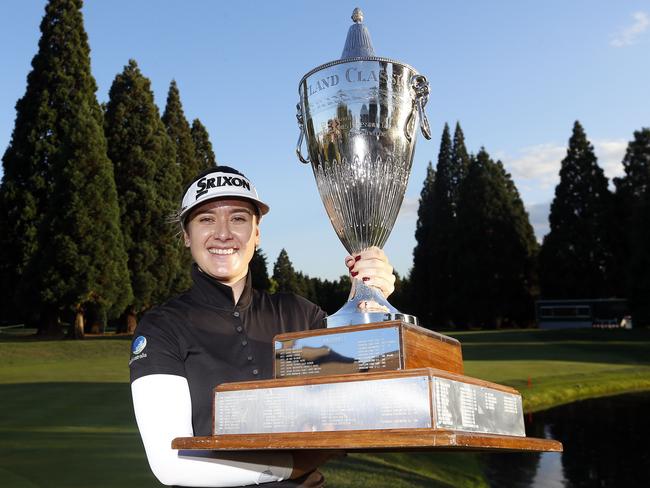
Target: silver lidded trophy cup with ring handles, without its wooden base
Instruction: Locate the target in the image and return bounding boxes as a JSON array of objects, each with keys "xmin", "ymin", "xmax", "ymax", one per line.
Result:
[{"xmin": 296, "ymin": 8, "xmax": 431, "ymax": 328}]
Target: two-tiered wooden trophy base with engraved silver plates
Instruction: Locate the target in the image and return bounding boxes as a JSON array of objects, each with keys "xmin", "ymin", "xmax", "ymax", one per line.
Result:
[{"xmin": 172, "ymin": 321, "xmax": 562, "ymax": 451}]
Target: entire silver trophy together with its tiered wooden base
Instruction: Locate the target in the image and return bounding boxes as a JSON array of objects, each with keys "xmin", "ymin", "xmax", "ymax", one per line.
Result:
[{"xmin": 172, "ymin": 9, "xmax": 562, "ymax": 451}]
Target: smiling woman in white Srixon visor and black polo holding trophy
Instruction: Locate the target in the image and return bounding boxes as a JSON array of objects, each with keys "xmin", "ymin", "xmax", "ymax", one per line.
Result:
[{"xmin": 129, "ymin": 166, "xmax": 395, "ymax": 487}]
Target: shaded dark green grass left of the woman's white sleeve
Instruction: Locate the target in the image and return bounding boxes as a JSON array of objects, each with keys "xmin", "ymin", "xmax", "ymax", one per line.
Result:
[{"xmin": 0, "ymin": 383, "xmax": 160, "ymax": 488}]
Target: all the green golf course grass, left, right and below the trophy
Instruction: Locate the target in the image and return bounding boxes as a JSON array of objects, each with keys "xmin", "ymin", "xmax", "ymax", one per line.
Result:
[{"xmin": 0, "ymin": 330, "xmax": 650, "ymax": 488}]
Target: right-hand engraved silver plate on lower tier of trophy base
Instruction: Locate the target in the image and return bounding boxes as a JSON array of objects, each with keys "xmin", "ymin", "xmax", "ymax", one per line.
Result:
[{"xmin": 431, "ymin": 376, "xmax": 526, "ymax": 437}]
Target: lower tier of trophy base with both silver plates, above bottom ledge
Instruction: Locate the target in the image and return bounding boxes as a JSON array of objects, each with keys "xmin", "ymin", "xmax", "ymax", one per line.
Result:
[{"xmin": 214, "ymin": 368, "xmax": 526, "ymax": 442}]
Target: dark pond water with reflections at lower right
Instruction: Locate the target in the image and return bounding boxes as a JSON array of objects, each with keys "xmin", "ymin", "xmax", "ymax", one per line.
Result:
[{"xmin": 483, "ymin": 393, "xmax": 650, "ymax": 488}]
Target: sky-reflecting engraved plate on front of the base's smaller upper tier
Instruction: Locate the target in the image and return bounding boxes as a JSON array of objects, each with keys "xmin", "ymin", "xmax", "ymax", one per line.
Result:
[{"xmin": 275, "ymin": 327, "xmax": 401, "ymax": 378}]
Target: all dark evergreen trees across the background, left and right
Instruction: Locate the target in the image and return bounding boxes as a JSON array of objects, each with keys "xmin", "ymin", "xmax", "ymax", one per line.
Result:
[{"xmin": 0, "ymin": 0, "xmax": 650, "ymax": 336}]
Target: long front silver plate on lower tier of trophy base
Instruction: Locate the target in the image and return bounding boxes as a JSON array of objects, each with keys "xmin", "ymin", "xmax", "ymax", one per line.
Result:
[{"xmin": 214, "ymin": 376, "xmax": 432, "ymax": 435}]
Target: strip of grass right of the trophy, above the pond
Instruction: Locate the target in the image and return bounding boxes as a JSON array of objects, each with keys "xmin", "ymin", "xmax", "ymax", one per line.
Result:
[{"xmin": 453, "ymin": 329, "xmax": 650, "ymax": 412}]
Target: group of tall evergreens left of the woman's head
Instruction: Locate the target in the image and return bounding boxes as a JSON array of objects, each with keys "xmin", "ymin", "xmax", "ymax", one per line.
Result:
[{"xmin": 0, "ymin": 0, "xmax": 216, "ymax": 336}]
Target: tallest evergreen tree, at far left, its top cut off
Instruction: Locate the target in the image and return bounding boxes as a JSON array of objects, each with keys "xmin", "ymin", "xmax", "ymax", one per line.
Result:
[{"xmin": 0, "ymin": 0, "xmax": 131, "ymax": 334}]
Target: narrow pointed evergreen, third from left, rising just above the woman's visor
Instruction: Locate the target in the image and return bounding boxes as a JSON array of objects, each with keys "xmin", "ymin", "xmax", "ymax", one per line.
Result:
[{"xmin": 162, "ymin": 80, "xmax": 199, "ymax": 188}]
